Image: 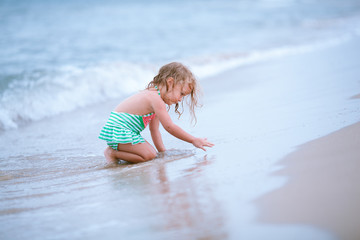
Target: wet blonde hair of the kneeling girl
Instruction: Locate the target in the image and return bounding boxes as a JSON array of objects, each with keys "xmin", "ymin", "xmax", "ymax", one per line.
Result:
[{"xmin": 147, "ymin": 62, "xmax": 200, "ymax": 124}]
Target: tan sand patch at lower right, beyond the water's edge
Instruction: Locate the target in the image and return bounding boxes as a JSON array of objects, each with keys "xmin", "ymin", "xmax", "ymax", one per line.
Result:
[{"xmin": 258, "ymin": 123, "xmax": 360, "ymax": 240}]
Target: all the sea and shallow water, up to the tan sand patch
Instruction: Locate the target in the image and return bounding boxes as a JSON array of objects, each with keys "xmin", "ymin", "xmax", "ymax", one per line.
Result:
[{"xmin": 0, "ymin": 0, "xmax": 360, "ymax": 240}]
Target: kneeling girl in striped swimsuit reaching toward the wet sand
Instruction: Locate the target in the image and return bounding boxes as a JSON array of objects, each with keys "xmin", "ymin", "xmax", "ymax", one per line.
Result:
[{"xmin": 99, "ymin": 62, "xmax": 214, "ymax": 163}]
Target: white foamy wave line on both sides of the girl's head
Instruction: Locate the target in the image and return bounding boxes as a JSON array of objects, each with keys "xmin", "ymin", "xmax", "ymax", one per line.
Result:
[{"xmin": 0, "ymin": 36, "xmax": 351, "ymax": 130}]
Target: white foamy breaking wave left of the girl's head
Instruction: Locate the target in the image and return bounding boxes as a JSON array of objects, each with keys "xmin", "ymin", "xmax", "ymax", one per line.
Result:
[{"xmin": 0, "ymin": 63, "xmax": 154, "ymax": 129}]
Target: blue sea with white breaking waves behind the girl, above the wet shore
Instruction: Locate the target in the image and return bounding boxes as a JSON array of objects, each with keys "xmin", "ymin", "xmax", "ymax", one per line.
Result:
[{"xmin": 0, "ymin": 0, "xmax": 360, "ymax": 130}]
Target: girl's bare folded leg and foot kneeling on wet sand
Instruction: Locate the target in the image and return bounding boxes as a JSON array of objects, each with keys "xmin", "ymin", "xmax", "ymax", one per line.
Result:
[{"xmin": 104, "ymin": 142, "xmax": 156, "ymax": 163}]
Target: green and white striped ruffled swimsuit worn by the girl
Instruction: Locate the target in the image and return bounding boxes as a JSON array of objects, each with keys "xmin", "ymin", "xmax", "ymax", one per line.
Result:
[{"xmin": 99, "ymin": 87, "xmax": 160, "ymax": 150}]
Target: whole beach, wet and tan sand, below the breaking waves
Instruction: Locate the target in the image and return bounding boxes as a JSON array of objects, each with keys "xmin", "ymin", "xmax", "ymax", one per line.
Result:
[{"xmin": 0, "ymin": 39, "xmax": 360, "ymax": 240}]
